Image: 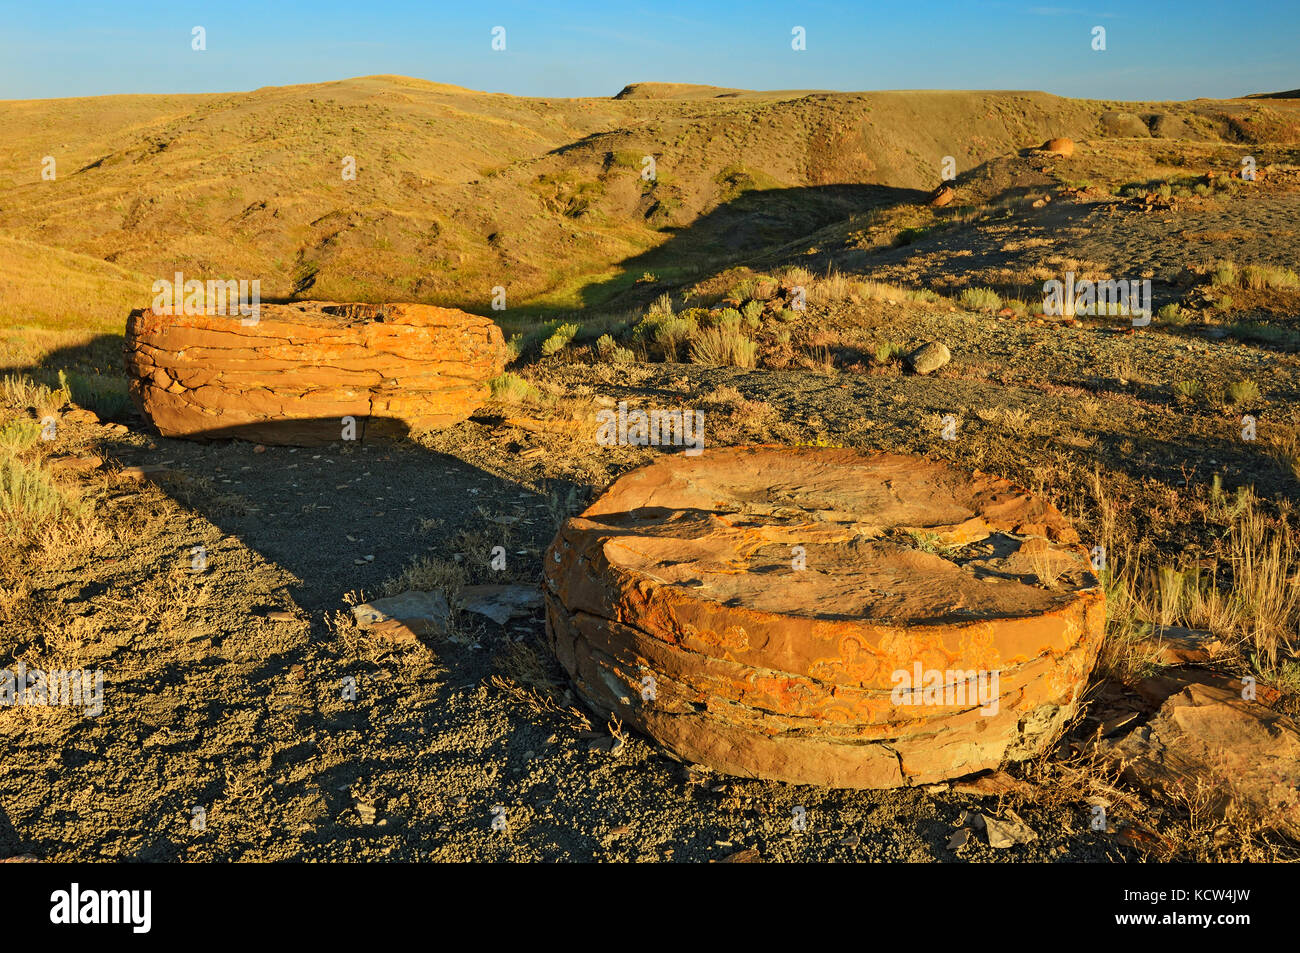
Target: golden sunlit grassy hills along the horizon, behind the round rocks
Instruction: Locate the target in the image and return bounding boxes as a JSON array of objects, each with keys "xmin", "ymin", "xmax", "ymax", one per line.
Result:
[{"xmin": 0, "ymin": 75, "xmax": 1294, "ymax": 338}]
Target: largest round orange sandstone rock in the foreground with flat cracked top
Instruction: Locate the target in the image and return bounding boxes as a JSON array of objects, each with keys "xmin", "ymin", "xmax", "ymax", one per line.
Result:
[{"xmin": 545, "ymin": 447, "xmax": 1105, "ymax": 788}]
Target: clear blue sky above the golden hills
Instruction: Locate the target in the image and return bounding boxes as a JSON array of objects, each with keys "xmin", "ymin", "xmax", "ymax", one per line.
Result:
[{"xmin": 0, "ymin": 0, "xmax": 1300, "ymax": 99}]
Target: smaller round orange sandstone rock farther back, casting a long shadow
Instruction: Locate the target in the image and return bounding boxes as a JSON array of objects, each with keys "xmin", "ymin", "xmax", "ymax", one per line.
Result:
[{"xmin": 126, "ymin": 302, "xmax": 506, "ymax": 446}]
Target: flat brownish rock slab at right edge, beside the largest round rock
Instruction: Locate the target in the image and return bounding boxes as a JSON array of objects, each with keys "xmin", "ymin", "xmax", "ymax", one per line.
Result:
[{"xmin": 1099, "ymin": 672, "xmax": 1300, "ymax": 837}]
